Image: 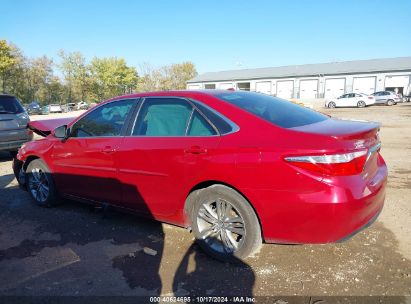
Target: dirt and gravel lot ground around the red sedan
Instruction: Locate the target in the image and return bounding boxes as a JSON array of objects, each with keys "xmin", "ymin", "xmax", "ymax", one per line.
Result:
[{"xmin": 0, "ymin": 103, "xmax": 411, "ymax": 303}]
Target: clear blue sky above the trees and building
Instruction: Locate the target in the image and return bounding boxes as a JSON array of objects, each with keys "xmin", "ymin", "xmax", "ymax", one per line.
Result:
[{"xmin": 0, "ymin": 0, "xmax": 411, "ymax": 73}]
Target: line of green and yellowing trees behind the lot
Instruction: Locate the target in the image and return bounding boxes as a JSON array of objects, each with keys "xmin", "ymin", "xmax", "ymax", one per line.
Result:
[{"xmin": 0, "ymin": 40, "xmax": 197, "ymax": 105}]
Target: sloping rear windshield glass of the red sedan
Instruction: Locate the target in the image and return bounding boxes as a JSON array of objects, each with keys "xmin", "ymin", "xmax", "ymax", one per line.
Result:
[{"xmin": 216, "ymin": 92, "xmax": 329, "ymax": 128}]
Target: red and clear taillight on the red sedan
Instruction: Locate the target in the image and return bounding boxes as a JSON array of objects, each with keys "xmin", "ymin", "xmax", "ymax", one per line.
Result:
[{"xmin": 284, "ymin": 150, "xmax": 368, "ymax": 175}]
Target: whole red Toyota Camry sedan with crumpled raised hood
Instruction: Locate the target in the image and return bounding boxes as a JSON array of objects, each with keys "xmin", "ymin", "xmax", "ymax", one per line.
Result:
[{"xmin": 14, "ymin": 90, "xmax": 387, "ymax": 260}]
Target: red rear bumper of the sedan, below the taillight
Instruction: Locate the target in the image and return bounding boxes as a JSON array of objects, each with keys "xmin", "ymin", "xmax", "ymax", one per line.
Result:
[{"xmin": 255, "ymin": 164, "xmax": 388, "ymax": 244}]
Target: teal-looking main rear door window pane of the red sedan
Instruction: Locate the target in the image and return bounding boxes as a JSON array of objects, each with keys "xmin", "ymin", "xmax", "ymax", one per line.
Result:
[{"xmin": 133, "ymin": 97, "xmax": 193, "ymax": 136}]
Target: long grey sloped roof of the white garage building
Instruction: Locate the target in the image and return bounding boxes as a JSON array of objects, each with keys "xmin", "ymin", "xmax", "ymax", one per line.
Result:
[{"xmin": 188, "ymin": 57, "xmax": 411, "ymax": 83}]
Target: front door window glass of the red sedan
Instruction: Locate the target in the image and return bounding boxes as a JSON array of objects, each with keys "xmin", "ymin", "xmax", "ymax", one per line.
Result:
[{"xmin": 70, "ymin": 99, "xmax": 135, "ymax": 138}]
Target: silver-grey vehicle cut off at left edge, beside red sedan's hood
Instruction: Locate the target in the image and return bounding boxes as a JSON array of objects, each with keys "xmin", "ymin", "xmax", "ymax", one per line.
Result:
[{"xmin": 0, "ymin": 94, "xmax": 33, "ymax": 156}]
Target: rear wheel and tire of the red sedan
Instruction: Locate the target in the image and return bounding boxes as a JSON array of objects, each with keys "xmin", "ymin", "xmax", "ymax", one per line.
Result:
[{"xmin": 188, "ymin": 185, "xmax": 262, "ymax": 262}]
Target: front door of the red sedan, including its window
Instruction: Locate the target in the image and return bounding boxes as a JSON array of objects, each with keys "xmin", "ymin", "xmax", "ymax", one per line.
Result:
[{"xmin": 51, "ymin": 99, "xmax": 135, "ymax": 205}]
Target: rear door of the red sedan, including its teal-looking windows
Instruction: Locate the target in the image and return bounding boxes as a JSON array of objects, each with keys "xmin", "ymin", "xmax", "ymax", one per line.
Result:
[{"xmin": 117, "ymin": 97, "xmax": 220, "ymax": 218}]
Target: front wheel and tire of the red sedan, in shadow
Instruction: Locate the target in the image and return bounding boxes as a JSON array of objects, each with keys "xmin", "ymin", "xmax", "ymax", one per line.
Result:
[{"xmin": 26, "ymin": 159, "xmax": 59, "ymax": 207}]
